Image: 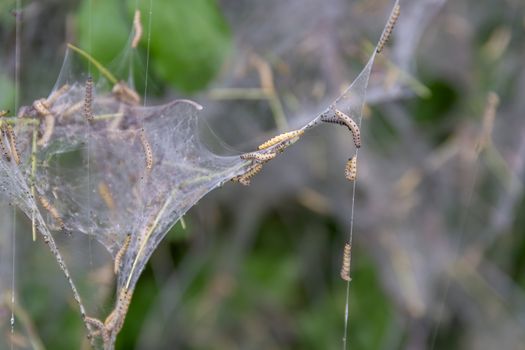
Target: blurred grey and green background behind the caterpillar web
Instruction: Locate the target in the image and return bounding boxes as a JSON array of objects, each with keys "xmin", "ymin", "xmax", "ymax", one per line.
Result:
[{"xmin": 0, "ymin": 0, "xmax": 525, "ymax": 349}]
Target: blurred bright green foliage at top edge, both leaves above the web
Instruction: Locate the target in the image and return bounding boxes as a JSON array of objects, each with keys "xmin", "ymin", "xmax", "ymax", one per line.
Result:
[{"xmin": 78, "ymin": 0, "xmax": 232, "ymax": 93}]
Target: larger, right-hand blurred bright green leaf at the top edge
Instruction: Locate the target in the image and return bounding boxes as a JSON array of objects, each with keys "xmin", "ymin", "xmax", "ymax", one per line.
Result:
[{"xmin": 132, "ymin": 0, "xmax": 231, "ymax": 92}]
